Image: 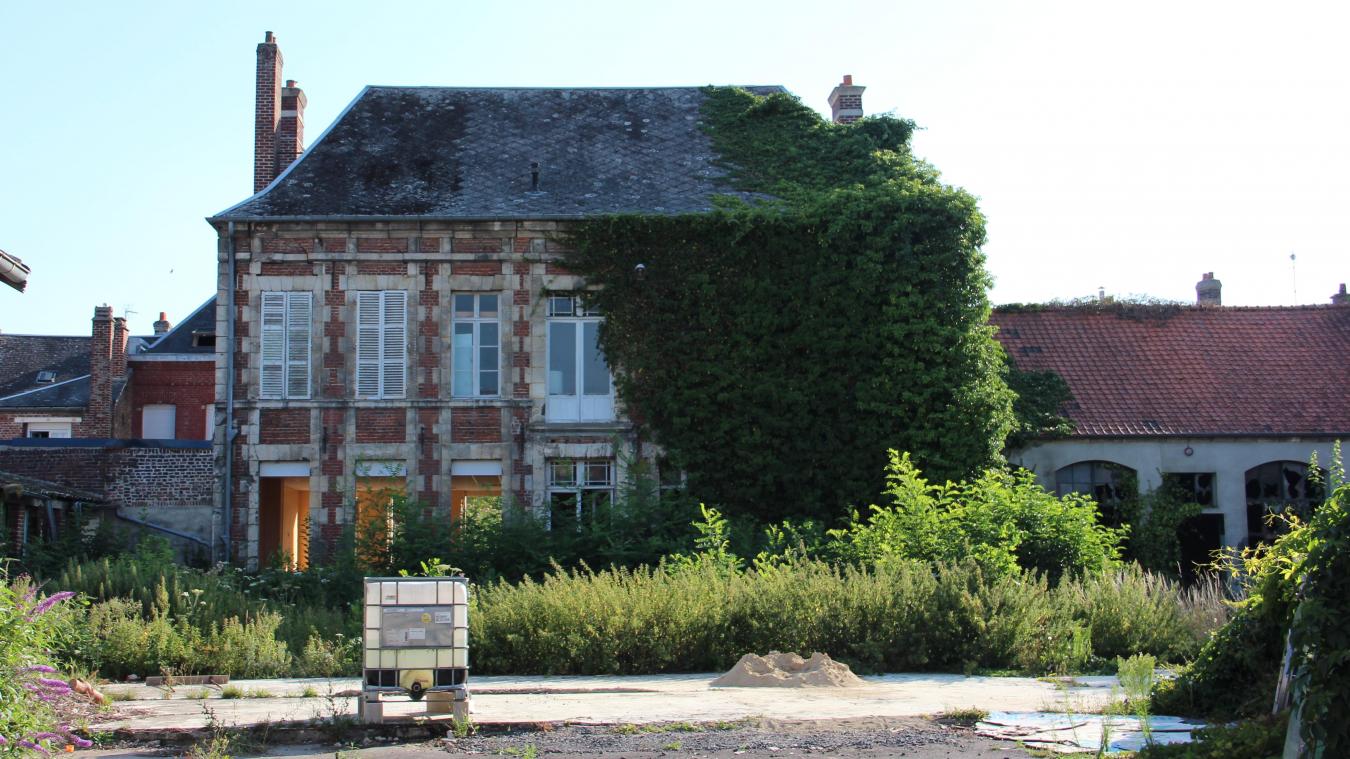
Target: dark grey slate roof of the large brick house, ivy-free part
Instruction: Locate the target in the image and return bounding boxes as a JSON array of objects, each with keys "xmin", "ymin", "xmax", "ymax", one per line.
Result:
[{"xmin": 215, "ymin": 86, "xmax": 783, "ymax": 220}]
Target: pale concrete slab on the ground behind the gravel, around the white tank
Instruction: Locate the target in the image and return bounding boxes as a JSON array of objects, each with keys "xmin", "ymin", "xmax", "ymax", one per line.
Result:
[{"xmin": 92, "ymin": 674, "xmax": 1112, "ymax": 733}]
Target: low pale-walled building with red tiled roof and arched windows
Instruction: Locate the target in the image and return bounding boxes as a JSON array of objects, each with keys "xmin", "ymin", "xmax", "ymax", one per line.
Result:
[{"xmin": 991, "ymin": 273, "xmax": 1350, "ymax": 566}]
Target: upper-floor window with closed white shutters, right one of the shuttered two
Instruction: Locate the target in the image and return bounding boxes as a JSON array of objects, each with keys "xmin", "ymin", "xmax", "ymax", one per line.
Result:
[{"xmin": 356, "ymin": 290, "xmax": 408, "ymax": 398}]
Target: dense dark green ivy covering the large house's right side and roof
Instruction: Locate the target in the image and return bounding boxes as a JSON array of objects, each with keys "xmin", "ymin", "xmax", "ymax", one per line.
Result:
[{"xmin": 564, "ymin": 88, "xmax": 1013, "ymax": 520}]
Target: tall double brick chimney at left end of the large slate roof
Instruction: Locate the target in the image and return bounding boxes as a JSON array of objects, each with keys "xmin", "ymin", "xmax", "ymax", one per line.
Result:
[{"xmin": 254, "ymin": 31, "xmax": 305, "ymax": 192}]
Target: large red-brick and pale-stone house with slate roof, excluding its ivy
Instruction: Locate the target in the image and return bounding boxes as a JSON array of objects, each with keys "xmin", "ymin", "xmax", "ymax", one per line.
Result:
[{"xmin": 208, "ymin": 32, "xmax": 864, "ymax": 565}]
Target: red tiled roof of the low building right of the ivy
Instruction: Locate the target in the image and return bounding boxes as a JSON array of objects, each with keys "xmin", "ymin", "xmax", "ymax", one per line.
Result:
[{"xmin": 990, "ymin": 305, "xmax": 1350, "ymax": 438}]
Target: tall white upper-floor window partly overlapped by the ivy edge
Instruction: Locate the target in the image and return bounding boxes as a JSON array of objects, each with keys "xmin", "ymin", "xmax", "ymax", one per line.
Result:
[{"xmin": 547, "ymin": 296, "xmax": 614, "ymax": 421}]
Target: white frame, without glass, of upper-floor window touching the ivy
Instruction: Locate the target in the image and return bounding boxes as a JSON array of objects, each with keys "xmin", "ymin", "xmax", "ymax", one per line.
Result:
[{"xmin": 545, "ymin": 294, "xmax": 614, "ymax": 421}]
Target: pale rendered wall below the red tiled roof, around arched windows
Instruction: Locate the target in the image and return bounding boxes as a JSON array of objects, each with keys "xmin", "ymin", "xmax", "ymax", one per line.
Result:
[{"xmin": 1008, "ymin": 438, "xmax": 1331, "ymax": 546}]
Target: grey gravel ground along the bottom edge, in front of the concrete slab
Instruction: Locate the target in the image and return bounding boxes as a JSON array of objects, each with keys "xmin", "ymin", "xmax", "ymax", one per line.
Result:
[{"xmin": 89, "ymin": 717, "xmax": 1033, "ymax": 759}]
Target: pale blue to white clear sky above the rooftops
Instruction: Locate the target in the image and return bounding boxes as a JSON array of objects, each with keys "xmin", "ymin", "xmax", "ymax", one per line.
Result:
[{"xmin": 0, "ymin": 0, "xmax": 1350, "ymax": 335}]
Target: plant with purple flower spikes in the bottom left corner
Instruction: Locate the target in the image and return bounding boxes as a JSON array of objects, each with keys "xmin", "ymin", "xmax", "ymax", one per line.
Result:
[{"xmin": 0, "ymin": 574, "xmax": 89, "ymax": 756}]
